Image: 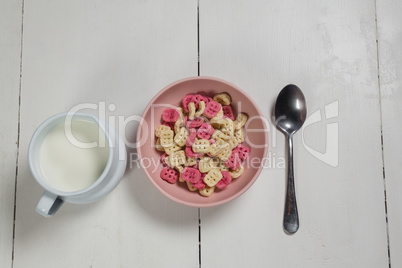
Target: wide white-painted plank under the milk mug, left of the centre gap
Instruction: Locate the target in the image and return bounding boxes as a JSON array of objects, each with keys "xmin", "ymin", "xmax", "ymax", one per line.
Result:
[{"xmin": 14, "ymin": 0, "xmax": 198, "ymax": 268}]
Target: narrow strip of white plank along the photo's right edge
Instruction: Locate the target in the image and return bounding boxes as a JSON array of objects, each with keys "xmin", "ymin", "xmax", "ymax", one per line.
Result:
[{"xmin": 377, "ymin": 1, "xmax": 402, "ymax": 267}]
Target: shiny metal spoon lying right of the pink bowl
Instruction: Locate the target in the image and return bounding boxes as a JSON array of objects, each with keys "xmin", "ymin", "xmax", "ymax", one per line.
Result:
[{"xmin": 275, "ymin": 85, "xmax": 307, "ymax": 234}]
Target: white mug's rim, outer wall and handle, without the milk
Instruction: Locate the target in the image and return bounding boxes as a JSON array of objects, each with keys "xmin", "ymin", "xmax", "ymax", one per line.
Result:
[{"xmin": 28, "ymin": 113, "xmax": 127, "ymax": 217}]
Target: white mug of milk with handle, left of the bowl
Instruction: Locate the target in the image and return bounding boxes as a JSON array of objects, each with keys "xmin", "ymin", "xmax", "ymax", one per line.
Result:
[{"xmin": 28, "ymin": 113, "xmax": 127, "ymax": 217}]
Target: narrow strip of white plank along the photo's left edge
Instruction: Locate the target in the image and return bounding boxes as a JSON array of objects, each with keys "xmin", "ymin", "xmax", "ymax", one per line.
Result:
[{"xmin": 0, "ymin": 1, "xmax": 22, "ymax": 267}]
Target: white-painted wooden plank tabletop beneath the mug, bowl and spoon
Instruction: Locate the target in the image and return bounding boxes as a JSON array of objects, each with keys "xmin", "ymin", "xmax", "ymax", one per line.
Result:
[{"xmin": 0, "ymin": 0, "xmax": 402, "ymax": 268}]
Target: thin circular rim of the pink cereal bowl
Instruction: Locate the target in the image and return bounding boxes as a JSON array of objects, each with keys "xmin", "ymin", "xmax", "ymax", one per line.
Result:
[{"xmin": 136, "ymin": 76, "xmax": 268, "ymax": 208}]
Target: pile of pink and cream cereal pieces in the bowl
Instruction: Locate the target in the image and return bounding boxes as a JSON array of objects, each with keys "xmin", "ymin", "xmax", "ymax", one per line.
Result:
[{"xmin": 155, "ymin": 93, "xmax": 250, "ymax": 197}]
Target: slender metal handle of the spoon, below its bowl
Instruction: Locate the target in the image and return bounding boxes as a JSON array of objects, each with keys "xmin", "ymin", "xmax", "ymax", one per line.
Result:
[{"xmin": 283, "ymin": 134, "xmax": 299, "ymax": 234}]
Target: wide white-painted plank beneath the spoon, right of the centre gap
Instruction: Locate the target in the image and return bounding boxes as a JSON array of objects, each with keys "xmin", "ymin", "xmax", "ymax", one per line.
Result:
[{"xmin": 200, "ymin": 0, "xmax": 390, "ymax": 267}]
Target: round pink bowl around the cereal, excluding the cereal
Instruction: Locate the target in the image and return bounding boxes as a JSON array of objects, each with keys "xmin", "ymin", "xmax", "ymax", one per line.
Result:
[{"xmin": 137, "ymin": 77, "xmax": 268, "ymax": 207}]
